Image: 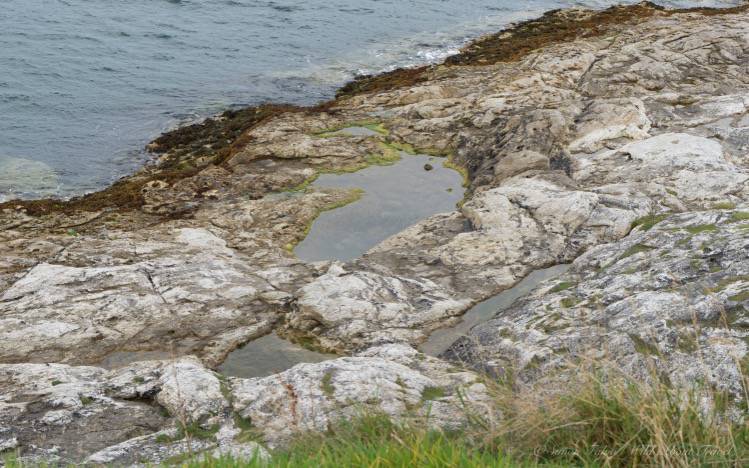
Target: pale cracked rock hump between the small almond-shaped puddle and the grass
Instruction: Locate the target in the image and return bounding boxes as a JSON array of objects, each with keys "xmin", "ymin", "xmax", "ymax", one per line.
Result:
[{"xmin": 230, "ymin": 345, "xmax": 491, "ymax": 444}]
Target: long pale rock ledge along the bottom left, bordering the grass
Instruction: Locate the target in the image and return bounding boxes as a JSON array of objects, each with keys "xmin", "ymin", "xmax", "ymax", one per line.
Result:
[{"xmin": 0, "ymin": 345, "xmax": 489, "ymax": 465}]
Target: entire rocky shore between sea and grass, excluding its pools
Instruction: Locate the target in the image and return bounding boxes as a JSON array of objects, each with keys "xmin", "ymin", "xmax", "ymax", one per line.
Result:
[{"xmin": 0, "ymin": 3, "xmax": 749, "ymax": 464}]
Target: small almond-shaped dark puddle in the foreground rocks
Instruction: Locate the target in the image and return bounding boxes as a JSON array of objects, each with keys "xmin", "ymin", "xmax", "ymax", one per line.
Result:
[{"xmin": 218, "ymin": 333, "xmax": 338, "ymax": 379}]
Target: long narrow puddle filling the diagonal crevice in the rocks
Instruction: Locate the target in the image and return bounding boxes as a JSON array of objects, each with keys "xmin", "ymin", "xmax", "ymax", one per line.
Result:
[{"xmin": 419, "ymin": 265, "xmax": 570, "ymax": 356}]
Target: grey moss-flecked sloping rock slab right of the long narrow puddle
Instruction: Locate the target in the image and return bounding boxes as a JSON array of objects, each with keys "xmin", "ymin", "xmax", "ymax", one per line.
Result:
[{"xmin": 445, "ymin": 209, "xmax": 749, "ymax": 399}]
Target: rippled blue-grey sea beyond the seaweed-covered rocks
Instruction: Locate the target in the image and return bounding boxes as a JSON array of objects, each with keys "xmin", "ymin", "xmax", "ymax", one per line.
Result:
[{"xmin": 0, "ymin": 0, "xmax": 737, "ymax": 200}]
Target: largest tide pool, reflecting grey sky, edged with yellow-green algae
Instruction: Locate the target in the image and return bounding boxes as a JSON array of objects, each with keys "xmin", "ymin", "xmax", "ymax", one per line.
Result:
[{"xmin": 294, "ymin": 149, "xmax": 464, "ymax": 262}]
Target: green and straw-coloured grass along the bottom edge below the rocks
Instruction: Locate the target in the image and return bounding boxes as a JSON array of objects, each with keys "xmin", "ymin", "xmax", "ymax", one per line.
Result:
[{"xmin": 169, "ymin": 368, "xmax": 749, "ymax": 468}]
